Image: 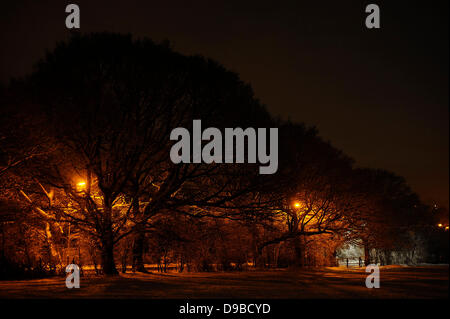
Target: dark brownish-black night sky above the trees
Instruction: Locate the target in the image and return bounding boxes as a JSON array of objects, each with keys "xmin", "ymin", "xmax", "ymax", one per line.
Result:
[{"xmin": 0, "ymin": 0, "xmax": 449, "ymax": 206}]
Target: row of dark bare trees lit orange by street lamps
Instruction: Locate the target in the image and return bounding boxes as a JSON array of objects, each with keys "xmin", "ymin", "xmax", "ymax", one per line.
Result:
[{"xmin": 0, "ymin": 33, "xmax": 448, "ymax": 278}]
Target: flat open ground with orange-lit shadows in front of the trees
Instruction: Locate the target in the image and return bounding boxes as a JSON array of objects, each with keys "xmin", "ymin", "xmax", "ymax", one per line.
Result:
[{"xmin": 0, "ymin": 265, "xmax": 449, "ymax": 299}]
